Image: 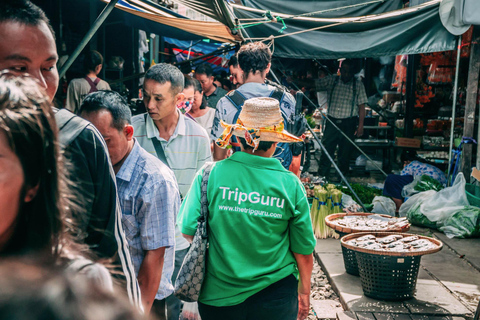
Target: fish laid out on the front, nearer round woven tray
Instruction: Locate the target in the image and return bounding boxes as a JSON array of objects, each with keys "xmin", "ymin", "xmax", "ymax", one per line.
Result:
[{"xmin": 345, "ymin": 234, "xmax": 439, "ymax": 252}]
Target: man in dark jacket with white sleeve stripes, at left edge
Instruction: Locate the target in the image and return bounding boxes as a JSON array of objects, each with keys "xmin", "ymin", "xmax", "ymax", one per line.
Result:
[{"xmin": 0, "ymin": 0, "xmax": 141, "ymax": 308}]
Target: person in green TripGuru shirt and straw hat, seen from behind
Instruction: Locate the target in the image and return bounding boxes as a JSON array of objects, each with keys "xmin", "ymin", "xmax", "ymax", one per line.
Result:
[{"xmin": 178, "ymin": 98, "xmax": 315, "ymax": 320}]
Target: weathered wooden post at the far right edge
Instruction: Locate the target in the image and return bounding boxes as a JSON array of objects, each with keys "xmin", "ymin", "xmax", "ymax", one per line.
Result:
[{"xmin": 462, "ymin": 26, "xmax": 480, "ymax": 182}]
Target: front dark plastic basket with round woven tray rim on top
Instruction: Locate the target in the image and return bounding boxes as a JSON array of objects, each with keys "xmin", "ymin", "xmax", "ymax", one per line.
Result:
[{"xmin": 341, "ymin": 232, "xmax": 443, "ymax": 301}]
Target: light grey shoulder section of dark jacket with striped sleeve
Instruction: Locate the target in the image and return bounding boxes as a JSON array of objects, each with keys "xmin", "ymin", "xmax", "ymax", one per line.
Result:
[{"xmin": 54, "ymin": 109, "xmax": 90, "ymax": 149}]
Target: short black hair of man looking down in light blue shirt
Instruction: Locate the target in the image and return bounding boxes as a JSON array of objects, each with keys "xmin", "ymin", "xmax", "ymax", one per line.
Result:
[{"xmin": 80, "ymin": 90, "xmax": 132, "ymax": 131}]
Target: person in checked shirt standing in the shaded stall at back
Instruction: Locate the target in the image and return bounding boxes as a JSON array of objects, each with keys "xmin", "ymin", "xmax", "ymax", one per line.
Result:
[{"xmin": 316, "ymin": 60, "xmax": 368, "ymax": 179}]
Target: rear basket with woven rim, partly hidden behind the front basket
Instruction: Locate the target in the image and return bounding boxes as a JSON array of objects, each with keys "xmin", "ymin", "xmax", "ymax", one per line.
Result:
[{"xmin": 325, "ymin": 212, "xmax": 410, "ymax": 276}]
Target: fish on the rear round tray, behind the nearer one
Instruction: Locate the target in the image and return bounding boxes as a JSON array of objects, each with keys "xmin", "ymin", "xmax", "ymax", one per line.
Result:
[{"xmin": 330, "ymin": 214, "xmax": 409, "ymax": 231}]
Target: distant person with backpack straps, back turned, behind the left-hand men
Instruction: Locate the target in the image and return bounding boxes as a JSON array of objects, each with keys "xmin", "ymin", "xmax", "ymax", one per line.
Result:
[{"xmin": 65, "ymin": 50, "xmax": 112, "ymax": 114}]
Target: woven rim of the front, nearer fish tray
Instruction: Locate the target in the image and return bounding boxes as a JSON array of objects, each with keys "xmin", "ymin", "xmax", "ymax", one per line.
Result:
[{"xmin": 340, "ymin": 232, "xmax": 443, "ymax": 257}]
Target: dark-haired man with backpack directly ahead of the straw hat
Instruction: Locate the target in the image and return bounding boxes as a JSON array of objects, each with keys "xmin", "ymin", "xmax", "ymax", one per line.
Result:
[{"xmin": 211, "ymin": 42, "xmax": 295, "ymax": 170}]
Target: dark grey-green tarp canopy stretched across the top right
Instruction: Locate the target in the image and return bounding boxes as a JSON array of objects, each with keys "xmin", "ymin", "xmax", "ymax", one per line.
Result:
[{"xmin": 176, "ymin": 0, "xmax": 455, "ymax": 59}]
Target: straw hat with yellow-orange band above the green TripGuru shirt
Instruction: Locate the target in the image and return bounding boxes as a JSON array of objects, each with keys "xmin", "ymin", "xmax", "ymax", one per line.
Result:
[{"xmin": 216, "ymin": 98, "xmax": 303, "ymax": 150}]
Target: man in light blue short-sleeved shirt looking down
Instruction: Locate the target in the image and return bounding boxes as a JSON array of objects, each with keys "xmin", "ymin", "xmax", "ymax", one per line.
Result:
[{"xmin": 80, "ymin": 91, "xmax": 180, "ymax": 319}]
